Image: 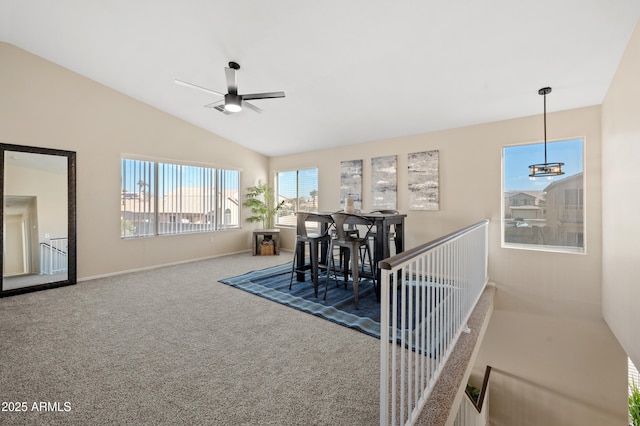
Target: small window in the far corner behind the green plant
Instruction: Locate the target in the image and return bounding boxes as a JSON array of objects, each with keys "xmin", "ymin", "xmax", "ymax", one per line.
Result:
[{"xmin": 276, "ymin": 168, "xmax": 319, "ymax": 226}]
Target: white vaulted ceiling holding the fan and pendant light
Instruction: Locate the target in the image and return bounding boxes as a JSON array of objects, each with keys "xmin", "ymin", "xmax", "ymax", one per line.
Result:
[{"xmin": 0, "ymin": 0, "xmax": 640, "ymax": 156}]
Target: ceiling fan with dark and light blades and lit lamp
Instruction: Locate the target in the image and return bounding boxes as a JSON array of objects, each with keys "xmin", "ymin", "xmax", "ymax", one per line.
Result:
[{"xmin": 174, "ymin": 61, "xmax": 284, "ymax": 114}]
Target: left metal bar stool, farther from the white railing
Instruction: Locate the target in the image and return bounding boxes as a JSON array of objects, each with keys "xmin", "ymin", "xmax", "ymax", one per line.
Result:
[{"xmin": 289, "ymin": 212, "xmax": 333, "ymax": 297}]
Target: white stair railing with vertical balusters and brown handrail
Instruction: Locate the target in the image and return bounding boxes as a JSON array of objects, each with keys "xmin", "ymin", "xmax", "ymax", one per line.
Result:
[{"xmin": 379, "ymin": 220, "xmax": 489, "ymax": 425}]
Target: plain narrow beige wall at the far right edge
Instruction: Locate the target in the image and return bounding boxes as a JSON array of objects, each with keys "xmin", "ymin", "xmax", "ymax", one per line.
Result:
[{"xmin": 602, "ymin": 24, "xmax": 640, "ymax": 367}]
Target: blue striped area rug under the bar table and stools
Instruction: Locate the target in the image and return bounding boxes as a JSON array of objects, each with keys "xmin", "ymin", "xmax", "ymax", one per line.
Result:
[{"xmin": 220, "ymin": 262, "xmax": 380, "ymax": 338}]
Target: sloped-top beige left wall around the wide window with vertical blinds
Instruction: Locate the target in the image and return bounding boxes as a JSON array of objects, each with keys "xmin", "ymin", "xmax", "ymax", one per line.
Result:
[{"xmin": 0, "ymin": 43, "xmax": 267, "ymax": 279}]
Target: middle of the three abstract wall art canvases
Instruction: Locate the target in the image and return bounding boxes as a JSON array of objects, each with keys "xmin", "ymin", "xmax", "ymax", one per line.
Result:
[{"xmin": 371, "ymin": 155, "xmax": 398, "ymax": 210}]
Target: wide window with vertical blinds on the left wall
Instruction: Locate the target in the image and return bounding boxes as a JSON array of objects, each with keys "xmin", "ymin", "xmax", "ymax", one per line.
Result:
[{"xmin": 120, "ymin": 159, "xmax": 240, "ymax": 238}]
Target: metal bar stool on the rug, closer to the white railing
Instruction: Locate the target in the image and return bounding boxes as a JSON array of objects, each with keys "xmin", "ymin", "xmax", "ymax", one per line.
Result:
[{"xmin": 324, "ymin": 213, "xmax": 376, "ymax": 309}]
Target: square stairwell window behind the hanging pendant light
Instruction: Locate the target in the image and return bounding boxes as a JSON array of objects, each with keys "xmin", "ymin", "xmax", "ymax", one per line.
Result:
[{"xmin": 502, "ymin": 139, "xmax": 585, "ymax": 253}]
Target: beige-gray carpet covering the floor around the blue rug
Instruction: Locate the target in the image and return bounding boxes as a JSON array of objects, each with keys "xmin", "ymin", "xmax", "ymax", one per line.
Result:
[{"xmin": 0, "ymin": 252, "xmax": 379, "ymax": 425}]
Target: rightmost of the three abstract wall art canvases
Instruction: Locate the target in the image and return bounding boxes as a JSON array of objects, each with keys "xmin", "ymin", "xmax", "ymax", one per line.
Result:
[{"xmin": 408, "ymin": 150, "xmax": 440, "ymax": 210}]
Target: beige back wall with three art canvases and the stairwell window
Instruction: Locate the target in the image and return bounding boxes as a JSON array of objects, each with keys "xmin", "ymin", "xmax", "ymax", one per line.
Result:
[{"xmin": 270, "ymin": 105, "xmax": 626, "ymax": 425}]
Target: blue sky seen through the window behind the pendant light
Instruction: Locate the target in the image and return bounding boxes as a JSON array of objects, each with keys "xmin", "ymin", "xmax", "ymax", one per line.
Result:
[{"xmin": 503, "ymin": 139, "xmax": 582, "ymax": 191}]
